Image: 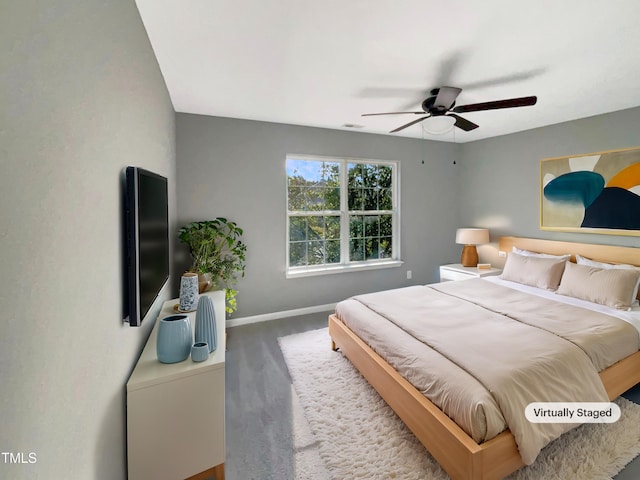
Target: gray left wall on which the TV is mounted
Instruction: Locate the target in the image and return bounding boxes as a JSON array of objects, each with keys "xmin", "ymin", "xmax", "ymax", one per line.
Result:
[{"xmin": 0, "ymin": 0, "xmax": 175, "ymax": 479}]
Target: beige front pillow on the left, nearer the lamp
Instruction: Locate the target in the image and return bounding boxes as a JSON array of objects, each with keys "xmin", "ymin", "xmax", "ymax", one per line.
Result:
[{"xmin": 500, "ymin": 253, "xmax": 567, "ymax": 291}]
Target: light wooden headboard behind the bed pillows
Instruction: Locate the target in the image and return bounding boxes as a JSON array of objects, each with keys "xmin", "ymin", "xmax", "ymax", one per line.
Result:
[{"xmin": 498, "ymin": 237, "xmax": 640, "ymax": 266}]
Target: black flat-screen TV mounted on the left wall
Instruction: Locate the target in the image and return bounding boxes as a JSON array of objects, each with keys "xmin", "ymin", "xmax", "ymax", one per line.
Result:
[{"xmin": 126, "ymin": 167, "xmax": 169, "ymax": 326}]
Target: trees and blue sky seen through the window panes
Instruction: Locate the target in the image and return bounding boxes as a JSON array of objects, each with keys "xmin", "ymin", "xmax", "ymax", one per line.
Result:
[{"xmin": 287, "ymin": 155, "xmax": 398, "ymax": 271}]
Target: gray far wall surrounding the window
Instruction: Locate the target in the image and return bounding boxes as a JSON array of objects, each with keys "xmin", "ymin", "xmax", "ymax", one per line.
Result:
[{"xmin": 175, "ymin": 114, "xmax": 460, "ymax": 318}]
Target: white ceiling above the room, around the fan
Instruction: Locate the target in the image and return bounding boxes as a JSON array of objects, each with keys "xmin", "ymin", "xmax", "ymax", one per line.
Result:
[{"xmin": 136, "ymin": 0, "xmax": 640, "ymax": 142}]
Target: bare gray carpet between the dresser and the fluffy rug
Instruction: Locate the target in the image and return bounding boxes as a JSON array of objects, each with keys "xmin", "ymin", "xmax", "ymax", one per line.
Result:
[{"xmin": 225, "ymin": 312, "xmax": 329, "ymax": 480}]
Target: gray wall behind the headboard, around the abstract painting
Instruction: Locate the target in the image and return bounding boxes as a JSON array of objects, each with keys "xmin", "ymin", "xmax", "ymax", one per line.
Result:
[{"xmin": 460, "ymin": 108, "xmax": 640, "ymax": 265}]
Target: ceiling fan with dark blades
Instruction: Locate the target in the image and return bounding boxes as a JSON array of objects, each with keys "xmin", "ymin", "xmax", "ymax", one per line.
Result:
[{"xmin": 362, "ymin": 87, "xmax": 538, "ymax": 133}]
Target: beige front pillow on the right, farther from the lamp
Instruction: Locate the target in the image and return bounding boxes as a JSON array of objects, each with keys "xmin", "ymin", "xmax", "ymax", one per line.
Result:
[{"xmin": 556, "ymin": 262, "xmax": 640, "ymax": 310}]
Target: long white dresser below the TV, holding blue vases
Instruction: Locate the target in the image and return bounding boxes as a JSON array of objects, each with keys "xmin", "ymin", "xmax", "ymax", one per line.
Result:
[{"xmin": 127, "ymin": 291, "xmax": 225, "ymax": 480}]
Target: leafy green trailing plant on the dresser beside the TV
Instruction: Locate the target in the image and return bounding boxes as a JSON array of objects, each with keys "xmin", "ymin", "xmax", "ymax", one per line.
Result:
[{"xmin": 178, "ymin": 217, "xmax": 247, "ymax": 313}]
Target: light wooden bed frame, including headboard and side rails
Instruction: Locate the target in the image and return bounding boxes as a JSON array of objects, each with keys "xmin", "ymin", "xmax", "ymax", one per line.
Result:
[{"xmin": 329, "ymin": 237, "xmax": 640, "ymax": 480}]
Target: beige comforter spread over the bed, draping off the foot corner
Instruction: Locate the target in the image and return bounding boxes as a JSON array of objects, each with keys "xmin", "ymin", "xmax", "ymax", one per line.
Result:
[{"xmin": 336, "ymin": 279, "xmax": 640, "ymax": 464}]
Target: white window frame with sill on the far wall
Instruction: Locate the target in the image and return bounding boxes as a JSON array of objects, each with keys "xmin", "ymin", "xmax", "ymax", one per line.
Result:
[{"xmin": 285, "ymin": 154, "xmax": 403, "ymax": 278}]
